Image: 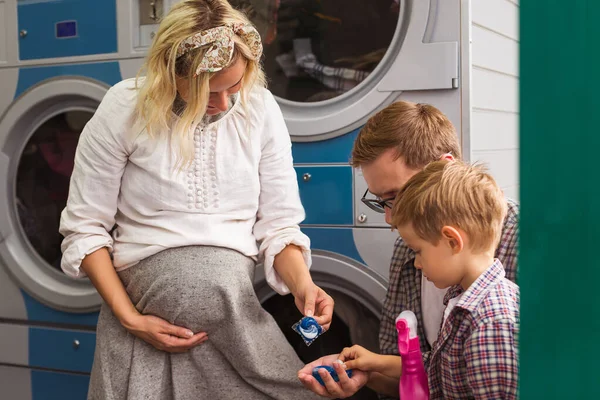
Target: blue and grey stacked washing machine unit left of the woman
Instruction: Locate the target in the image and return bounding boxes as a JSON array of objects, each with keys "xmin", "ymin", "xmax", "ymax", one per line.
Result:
[{"xmin": 0, "ymin": 0, "xmax": 160, "ymax": 400}]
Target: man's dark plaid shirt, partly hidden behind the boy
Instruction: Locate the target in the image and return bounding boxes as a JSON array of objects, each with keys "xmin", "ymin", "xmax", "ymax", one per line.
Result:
[{"xmin": 379, "ymin": 200, "xmax": 519, "ymax": 398}]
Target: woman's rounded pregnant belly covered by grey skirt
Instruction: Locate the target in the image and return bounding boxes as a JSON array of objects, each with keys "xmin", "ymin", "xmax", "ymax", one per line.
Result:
[{"xmin": 119, "ymin": 246, "xmax": 260, "ymax": 335}]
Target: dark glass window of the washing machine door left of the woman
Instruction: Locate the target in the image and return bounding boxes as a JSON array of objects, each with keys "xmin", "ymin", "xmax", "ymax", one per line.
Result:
[{"xmin": 15, "ymin": 110, "xmax": 93, "ymax": 270}]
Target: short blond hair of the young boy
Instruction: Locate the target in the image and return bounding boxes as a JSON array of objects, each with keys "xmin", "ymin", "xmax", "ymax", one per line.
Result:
[{"xmin": 392, "ymin": 160, "xmax": 507, "ymax": 252}]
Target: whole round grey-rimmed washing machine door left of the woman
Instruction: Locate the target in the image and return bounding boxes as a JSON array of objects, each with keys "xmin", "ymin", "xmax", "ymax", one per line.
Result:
[{"xmin": 0, "ymin": 77, "xmax": 108, "ymax": 312}]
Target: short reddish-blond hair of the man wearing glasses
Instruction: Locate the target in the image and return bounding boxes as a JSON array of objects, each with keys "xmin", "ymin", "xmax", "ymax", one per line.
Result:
[{"xmin": 350, "ymin": 101, "xmax": 461, "ymax": 169}]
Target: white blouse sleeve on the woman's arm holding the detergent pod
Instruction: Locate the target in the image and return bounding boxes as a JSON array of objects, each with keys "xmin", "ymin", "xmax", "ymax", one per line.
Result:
[{"xmin": 254, "ymin": 92, "xmax": 311, "ymax": 295}]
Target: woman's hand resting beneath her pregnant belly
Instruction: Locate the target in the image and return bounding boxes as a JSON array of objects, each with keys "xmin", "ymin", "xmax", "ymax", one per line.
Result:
[{"xmin": 123, "ymin": 314, "xmax": 208, "ymax": 353}]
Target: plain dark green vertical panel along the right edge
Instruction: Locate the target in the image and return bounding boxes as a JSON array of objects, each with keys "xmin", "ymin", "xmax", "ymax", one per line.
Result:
[{"xmin": 519, "ymin": 0, "xmax": 600, "ymax": 400}]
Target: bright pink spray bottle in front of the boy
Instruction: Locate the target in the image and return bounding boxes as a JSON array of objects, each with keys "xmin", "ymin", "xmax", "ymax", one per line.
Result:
[{"xmin": 396, "ymin": 311, "xmax": 429, "ymax": 400}]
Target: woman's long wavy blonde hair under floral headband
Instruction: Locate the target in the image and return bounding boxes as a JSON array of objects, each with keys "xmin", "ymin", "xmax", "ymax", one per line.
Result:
[{"xmin": 135, "ymin": 0, "xmax": 266, "ymax": 166}]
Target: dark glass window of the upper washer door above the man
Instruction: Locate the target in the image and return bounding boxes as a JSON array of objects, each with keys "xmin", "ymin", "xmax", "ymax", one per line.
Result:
[{"xmin": 230, "ymin": 0, "xmax": 400, "ymax": 103}]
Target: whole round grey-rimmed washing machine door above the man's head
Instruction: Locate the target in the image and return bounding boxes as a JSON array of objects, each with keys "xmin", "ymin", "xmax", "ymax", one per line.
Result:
[{"xmin": 230, "ymin": 0, "xmax": 458, "ymax": 141}]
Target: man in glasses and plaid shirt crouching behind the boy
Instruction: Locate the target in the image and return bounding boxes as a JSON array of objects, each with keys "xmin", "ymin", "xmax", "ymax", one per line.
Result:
[{"xmin": 298, "ymin": 101, "xmax": 519, "ymax": 398}]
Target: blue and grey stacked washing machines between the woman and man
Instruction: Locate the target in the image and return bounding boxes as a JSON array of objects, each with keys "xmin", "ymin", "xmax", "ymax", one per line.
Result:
[{"xmin": 241, "ymin": 0, "xmax": 470, "ymax": 399}]
